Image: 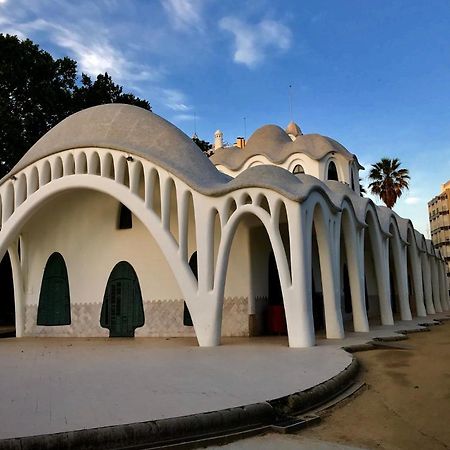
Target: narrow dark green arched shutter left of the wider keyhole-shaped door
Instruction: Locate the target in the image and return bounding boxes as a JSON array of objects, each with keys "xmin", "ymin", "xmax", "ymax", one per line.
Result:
[{"xmin": 37, "ymin": 253, "xmax": 71, "ymax": 326}]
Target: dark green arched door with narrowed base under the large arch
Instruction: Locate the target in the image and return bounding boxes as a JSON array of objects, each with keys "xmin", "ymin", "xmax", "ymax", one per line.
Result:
[{"xmin": 100, "ymin": 261, "xmax": 144, "ymax": 337}]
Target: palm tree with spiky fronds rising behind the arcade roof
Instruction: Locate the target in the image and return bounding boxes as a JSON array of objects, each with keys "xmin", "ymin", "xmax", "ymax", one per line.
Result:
[{"xmin": 369, "ymin": 158, "xmax": 410, "ymax": 209}]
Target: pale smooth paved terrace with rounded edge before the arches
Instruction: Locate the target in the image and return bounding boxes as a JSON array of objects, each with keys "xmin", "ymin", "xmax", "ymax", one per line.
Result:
[{"xmin": 0, "ymin": 316, "xmax": 444, "ymax": 439}]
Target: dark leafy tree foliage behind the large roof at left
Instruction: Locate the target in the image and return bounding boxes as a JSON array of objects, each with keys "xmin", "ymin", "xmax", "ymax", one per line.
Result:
[{"xmin": 0, "ymin": 34, "xmax": 151, "ymax": 176}]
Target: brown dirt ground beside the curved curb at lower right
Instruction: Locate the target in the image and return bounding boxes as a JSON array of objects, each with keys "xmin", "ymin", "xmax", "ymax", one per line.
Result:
[{"xmin": 297, "ymin": 321, "xmax": 450, "ymax": 450}]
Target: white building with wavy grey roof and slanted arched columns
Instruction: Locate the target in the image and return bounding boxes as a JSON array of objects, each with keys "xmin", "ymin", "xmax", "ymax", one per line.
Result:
[{"xmin": 0, "ymin": 104, "xmax": 449, "ymax": 347}]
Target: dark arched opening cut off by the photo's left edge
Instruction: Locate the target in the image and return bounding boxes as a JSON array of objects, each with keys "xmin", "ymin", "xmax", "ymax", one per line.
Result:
[{"xmin": 0, "ymin": 252, "xmax": 15, "ymax": 336}]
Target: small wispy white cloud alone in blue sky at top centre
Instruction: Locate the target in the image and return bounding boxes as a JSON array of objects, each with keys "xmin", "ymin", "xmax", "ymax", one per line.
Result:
[{"xmin": 219, "ymin": 16, "xmax": 292, "ymax": 67}]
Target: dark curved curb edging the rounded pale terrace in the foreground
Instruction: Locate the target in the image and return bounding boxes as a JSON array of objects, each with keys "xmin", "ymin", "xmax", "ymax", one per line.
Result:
[{"xmin": 0, "ymin": 358, "xmax": 358, "ymax": 450}]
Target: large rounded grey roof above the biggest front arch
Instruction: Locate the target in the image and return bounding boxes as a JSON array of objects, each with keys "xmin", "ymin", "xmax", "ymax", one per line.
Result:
[{"xmin": 9, "ymin": 103, "xmax": 226, "ymax": 185}]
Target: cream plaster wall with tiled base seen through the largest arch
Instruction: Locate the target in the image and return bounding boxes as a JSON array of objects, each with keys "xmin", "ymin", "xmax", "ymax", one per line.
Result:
[{"xmin": 21, "ymin": 190, "xmax": 193, "ymax": 336}]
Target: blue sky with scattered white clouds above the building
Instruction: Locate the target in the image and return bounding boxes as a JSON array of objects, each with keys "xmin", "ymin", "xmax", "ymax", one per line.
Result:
[{"xmin": 0, "ymin": 0, "xmax": 450, "ymax": 232}]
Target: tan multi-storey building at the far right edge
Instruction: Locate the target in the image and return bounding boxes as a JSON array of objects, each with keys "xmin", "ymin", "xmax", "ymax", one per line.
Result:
[{"xmin": 428, "ymin": 180, "xmax": 450, "ymax": 296}]
